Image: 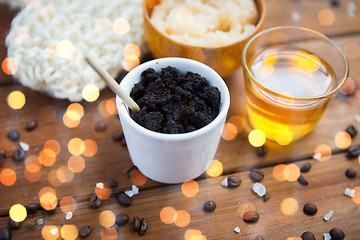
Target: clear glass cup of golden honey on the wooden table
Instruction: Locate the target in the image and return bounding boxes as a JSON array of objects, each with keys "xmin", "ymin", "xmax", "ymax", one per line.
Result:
[{"xmin": 242, "ymin": 26, "xmax": 349, "ymax": 145}]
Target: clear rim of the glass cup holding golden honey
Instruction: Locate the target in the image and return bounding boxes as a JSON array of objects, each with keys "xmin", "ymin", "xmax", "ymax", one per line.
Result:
[{"xmin": 242, "ymin": 26, "xmax": 349, "ymax": 101}]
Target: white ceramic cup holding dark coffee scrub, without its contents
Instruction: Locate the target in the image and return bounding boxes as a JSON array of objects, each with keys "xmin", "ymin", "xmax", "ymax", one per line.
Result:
[{"xmin": 116, "ymin": 58, "xmax": 230, "ymax": 183}]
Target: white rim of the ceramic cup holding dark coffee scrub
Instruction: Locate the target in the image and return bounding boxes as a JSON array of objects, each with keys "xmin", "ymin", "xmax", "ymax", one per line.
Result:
[{"xmin": 116, "ymin": 57, "xmax": 230, "ymax": 141}]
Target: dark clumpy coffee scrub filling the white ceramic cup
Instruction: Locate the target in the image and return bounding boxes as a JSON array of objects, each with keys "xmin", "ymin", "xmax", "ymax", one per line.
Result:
[{"xmin": 130, "ymin": 66, "xmax": 220, "ymax": 134}]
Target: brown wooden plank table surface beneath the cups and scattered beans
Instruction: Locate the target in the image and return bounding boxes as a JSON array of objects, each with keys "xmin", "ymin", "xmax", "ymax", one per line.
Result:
[{"xmin": 0, "ymin": 0, "xmax": 360, "ymax": 240}]
